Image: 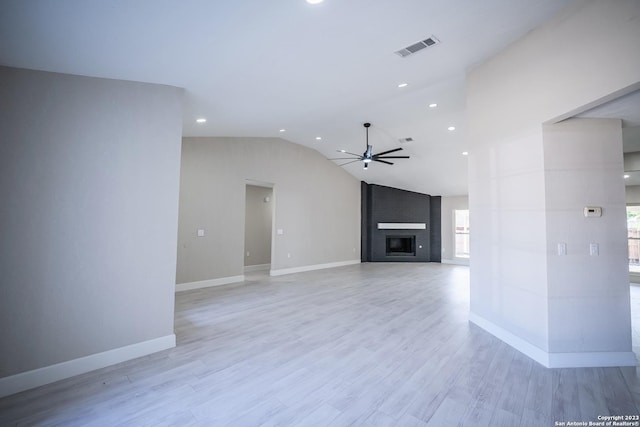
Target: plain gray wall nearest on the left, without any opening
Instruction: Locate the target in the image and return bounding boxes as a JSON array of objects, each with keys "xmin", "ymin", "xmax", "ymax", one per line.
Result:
[{"xmin": 0, "ymin": 67, "xmax": 182, "ymax": 377}]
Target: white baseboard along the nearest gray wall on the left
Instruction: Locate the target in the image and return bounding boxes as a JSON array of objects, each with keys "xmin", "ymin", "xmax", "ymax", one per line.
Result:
[{"xmin": 0, "ymin": 334, "xmax": 176, "ymax": 397}]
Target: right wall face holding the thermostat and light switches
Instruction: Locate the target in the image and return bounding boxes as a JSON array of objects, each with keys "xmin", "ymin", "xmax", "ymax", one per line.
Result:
[{"xmin": 543, "ymin": 119, "xmax": 631, "ymax": 353}]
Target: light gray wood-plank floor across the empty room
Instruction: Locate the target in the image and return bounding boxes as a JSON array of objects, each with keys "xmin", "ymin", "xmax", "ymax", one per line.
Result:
[{"xmin": 0, "ymin": 264, "xmax": 640, "ymax": 427}]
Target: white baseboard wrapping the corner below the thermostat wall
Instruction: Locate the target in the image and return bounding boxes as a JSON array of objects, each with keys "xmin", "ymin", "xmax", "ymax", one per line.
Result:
[{"xmin": 469, "ymin": 313, "xmax": 637, "ymax": 368}]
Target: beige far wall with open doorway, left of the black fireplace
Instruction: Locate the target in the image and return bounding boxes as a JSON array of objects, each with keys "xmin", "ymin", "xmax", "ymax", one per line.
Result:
[{"xmin": 176, "ymin": 138, "xmax": 360, "ymax": 283}]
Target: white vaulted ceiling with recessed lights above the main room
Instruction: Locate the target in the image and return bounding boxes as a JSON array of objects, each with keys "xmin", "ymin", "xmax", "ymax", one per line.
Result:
[{"xmin": 0, "ymin": 0, "xmax": 570, "ymax": 195}]
